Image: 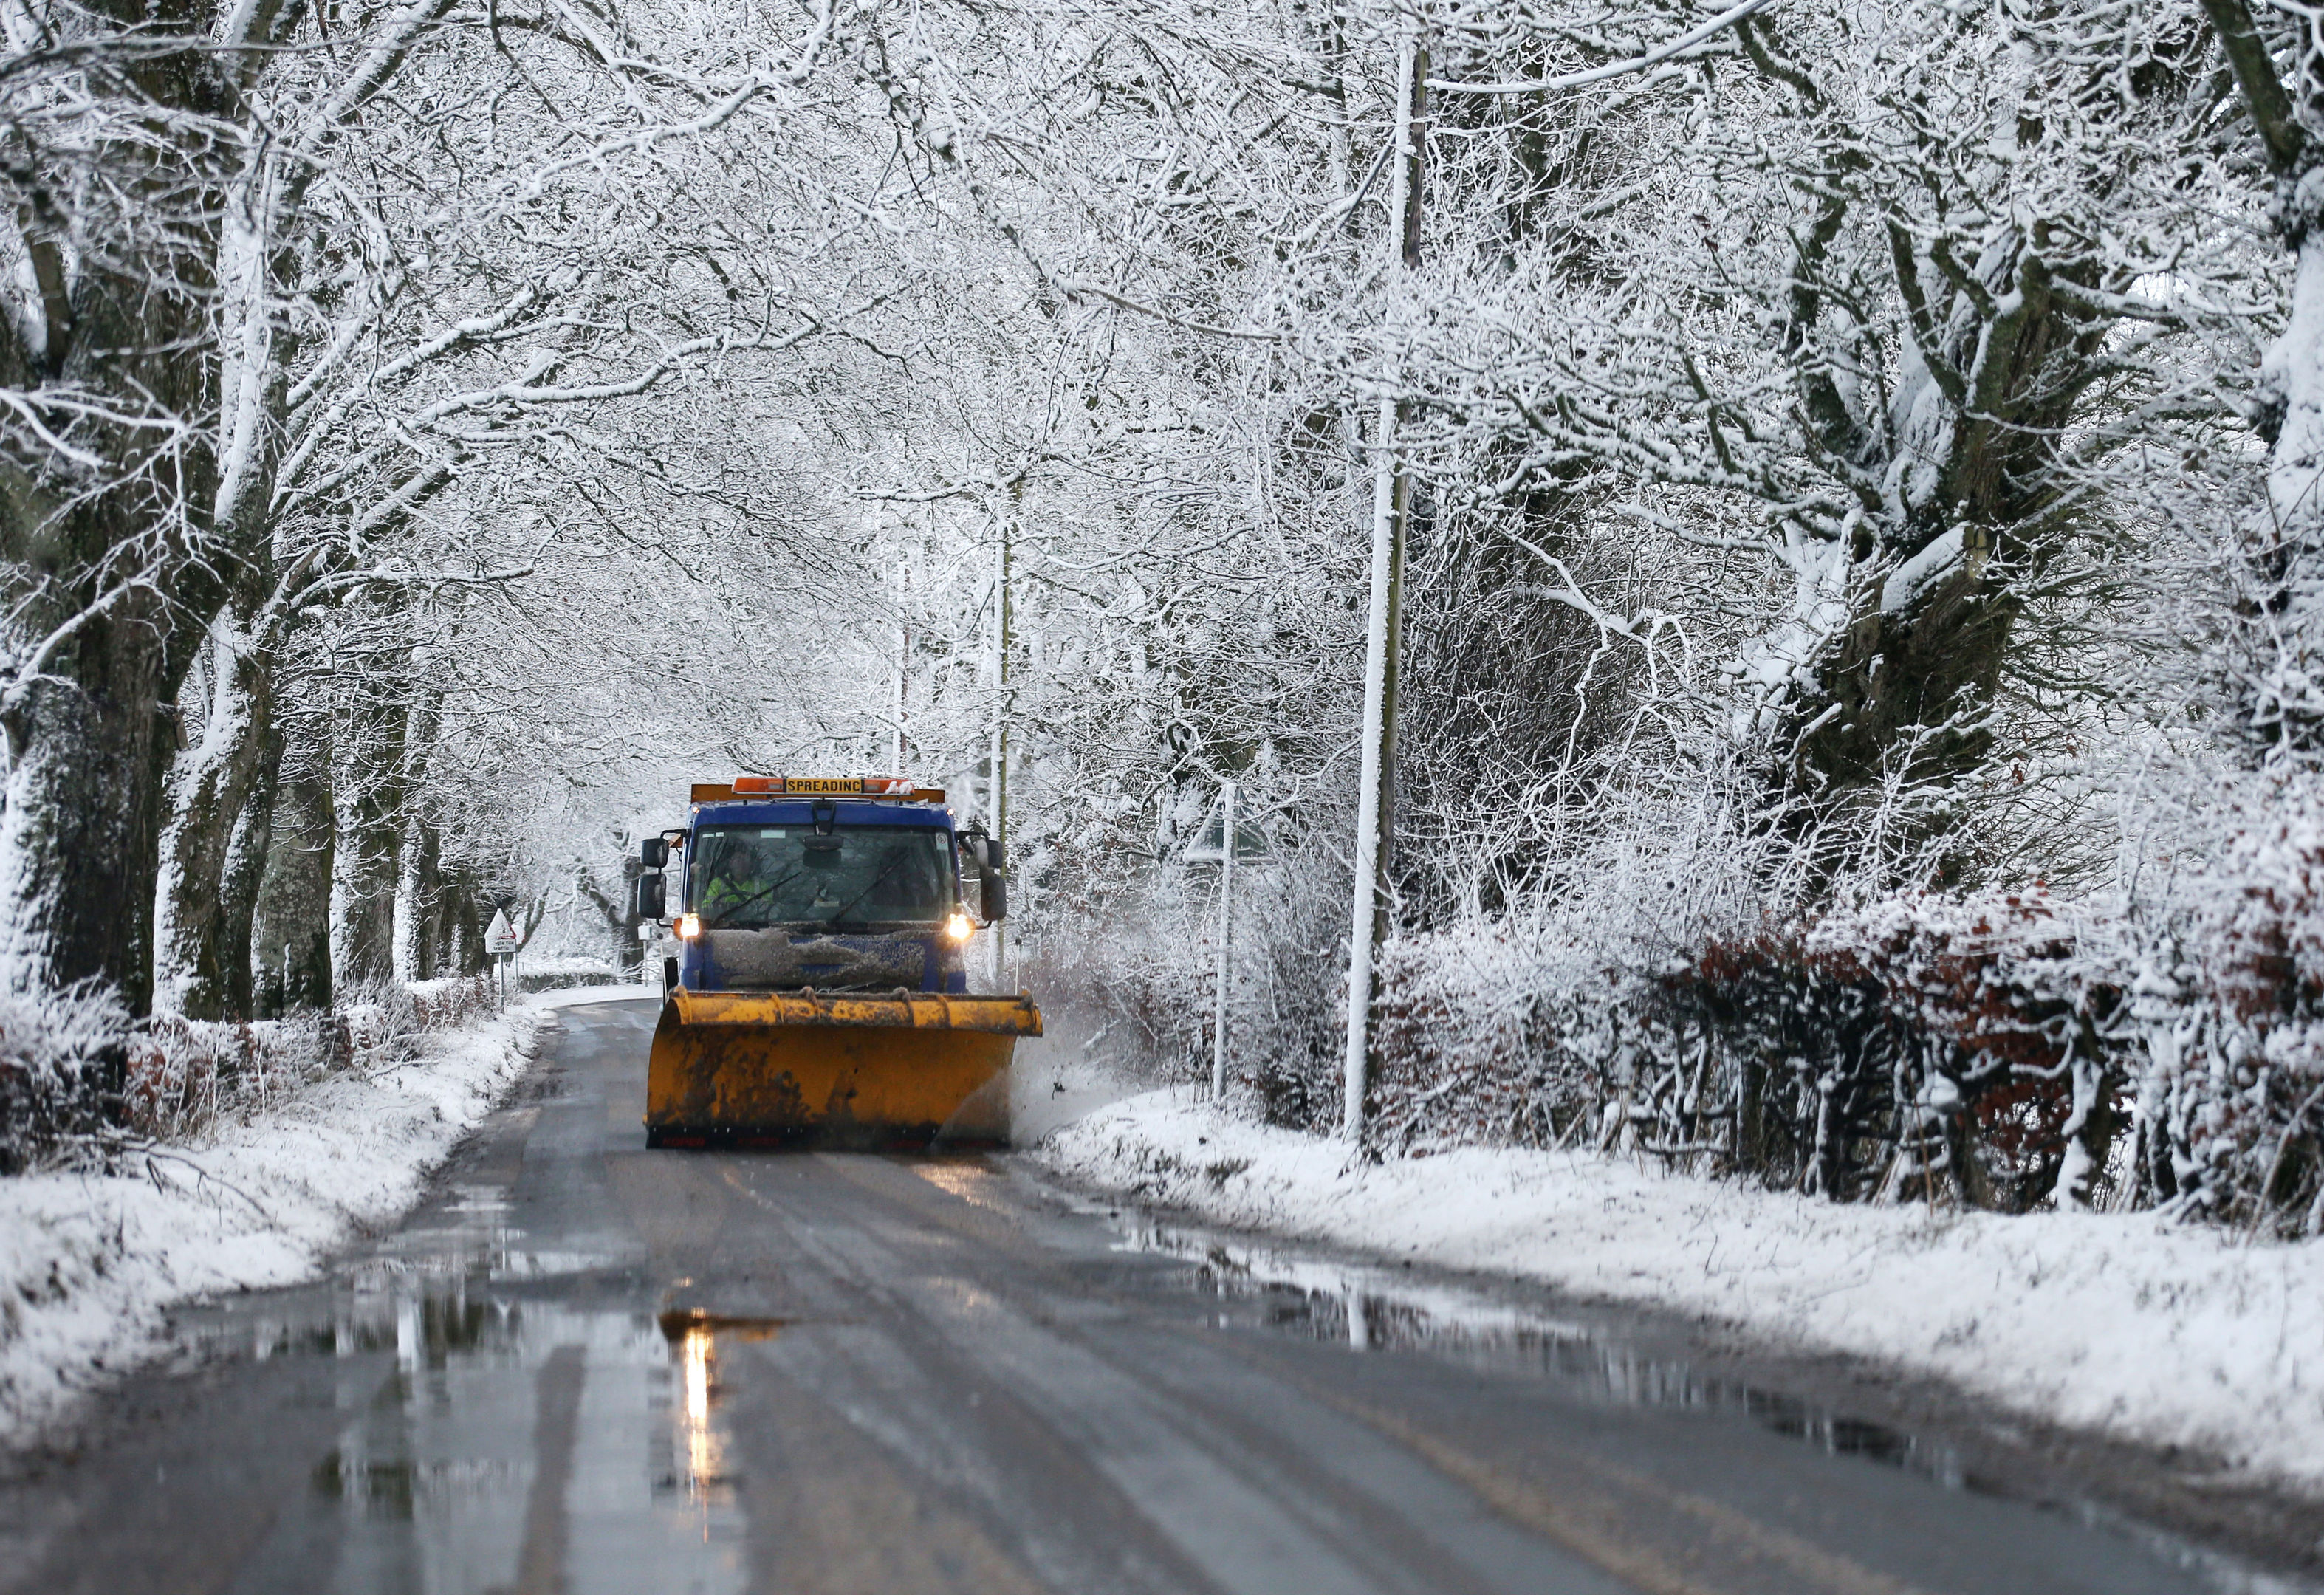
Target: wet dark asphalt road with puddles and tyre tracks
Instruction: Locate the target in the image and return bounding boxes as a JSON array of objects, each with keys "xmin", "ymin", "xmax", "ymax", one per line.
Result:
[{"xmin": 0, "ymin": 1002, "xmax": 2301, "ymax": 1595}]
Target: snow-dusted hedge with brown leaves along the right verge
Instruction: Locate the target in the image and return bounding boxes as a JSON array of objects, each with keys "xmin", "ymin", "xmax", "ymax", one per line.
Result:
[{"xmin": 1083, "ymin": 786, "xmax": 2324, "ymax": 1239}]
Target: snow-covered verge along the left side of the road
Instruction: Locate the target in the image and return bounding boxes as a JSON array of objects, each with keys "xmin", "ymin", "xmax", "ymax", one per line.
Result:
[{"xmin": 0, "ymin": 992, "xmax": 552, "ymax": 1444}]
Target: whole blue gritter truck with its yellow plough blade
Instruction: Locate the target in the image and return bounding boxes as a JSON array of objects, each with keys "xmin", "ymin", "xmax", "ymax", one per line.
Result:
[{"xmin": 634, "ymin": 777, "xmax": 1041, "ymax": 1146}]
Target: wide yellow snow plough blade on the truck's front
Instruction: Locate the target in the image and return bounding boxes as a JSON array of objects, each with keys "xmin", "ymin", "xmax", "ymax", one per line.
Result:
[{"xmin": 646, "ymin": 988, "xmax": 1041, "ymax": 1146}]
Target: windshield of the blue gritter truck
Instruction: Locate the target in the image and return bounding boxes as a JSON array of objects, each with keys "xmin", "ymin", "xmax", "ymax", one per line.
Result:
[{"xmin": 688, "ymin": 826, "xmax": 953, "ymax": 930}]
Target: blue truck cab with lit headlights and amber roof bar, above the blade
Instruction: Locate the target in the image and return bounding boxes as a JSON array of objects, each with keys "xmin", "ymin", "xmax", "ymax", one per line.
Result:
[{"xmin": 637, "ymin": 777, "xmax": 1004, "ymax": 995}]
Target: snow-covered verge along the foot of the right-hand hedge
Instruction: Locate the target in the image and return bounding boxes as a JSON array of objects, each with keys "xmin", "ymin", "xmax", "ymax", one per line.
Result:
[{"xmin": 1037, "ymin": 1091, "xmax": 2324, "ymax": 1492}]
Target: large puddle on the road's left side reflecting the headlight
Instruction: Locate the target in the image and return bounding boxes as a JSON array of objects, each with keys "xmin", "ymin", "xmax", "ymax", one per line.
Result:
[{"xmin": 152, "ymin": 1190, "xmax": 753, "ymax": 1595}]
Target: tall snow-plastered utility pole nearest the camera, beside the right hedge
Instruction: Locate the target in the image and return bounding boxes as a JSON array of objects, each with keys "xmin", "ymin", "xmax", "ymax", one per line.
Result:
[{"xmin": 1341, "ymin": 23, "xmax": 1429, "ymax": 1146}]
